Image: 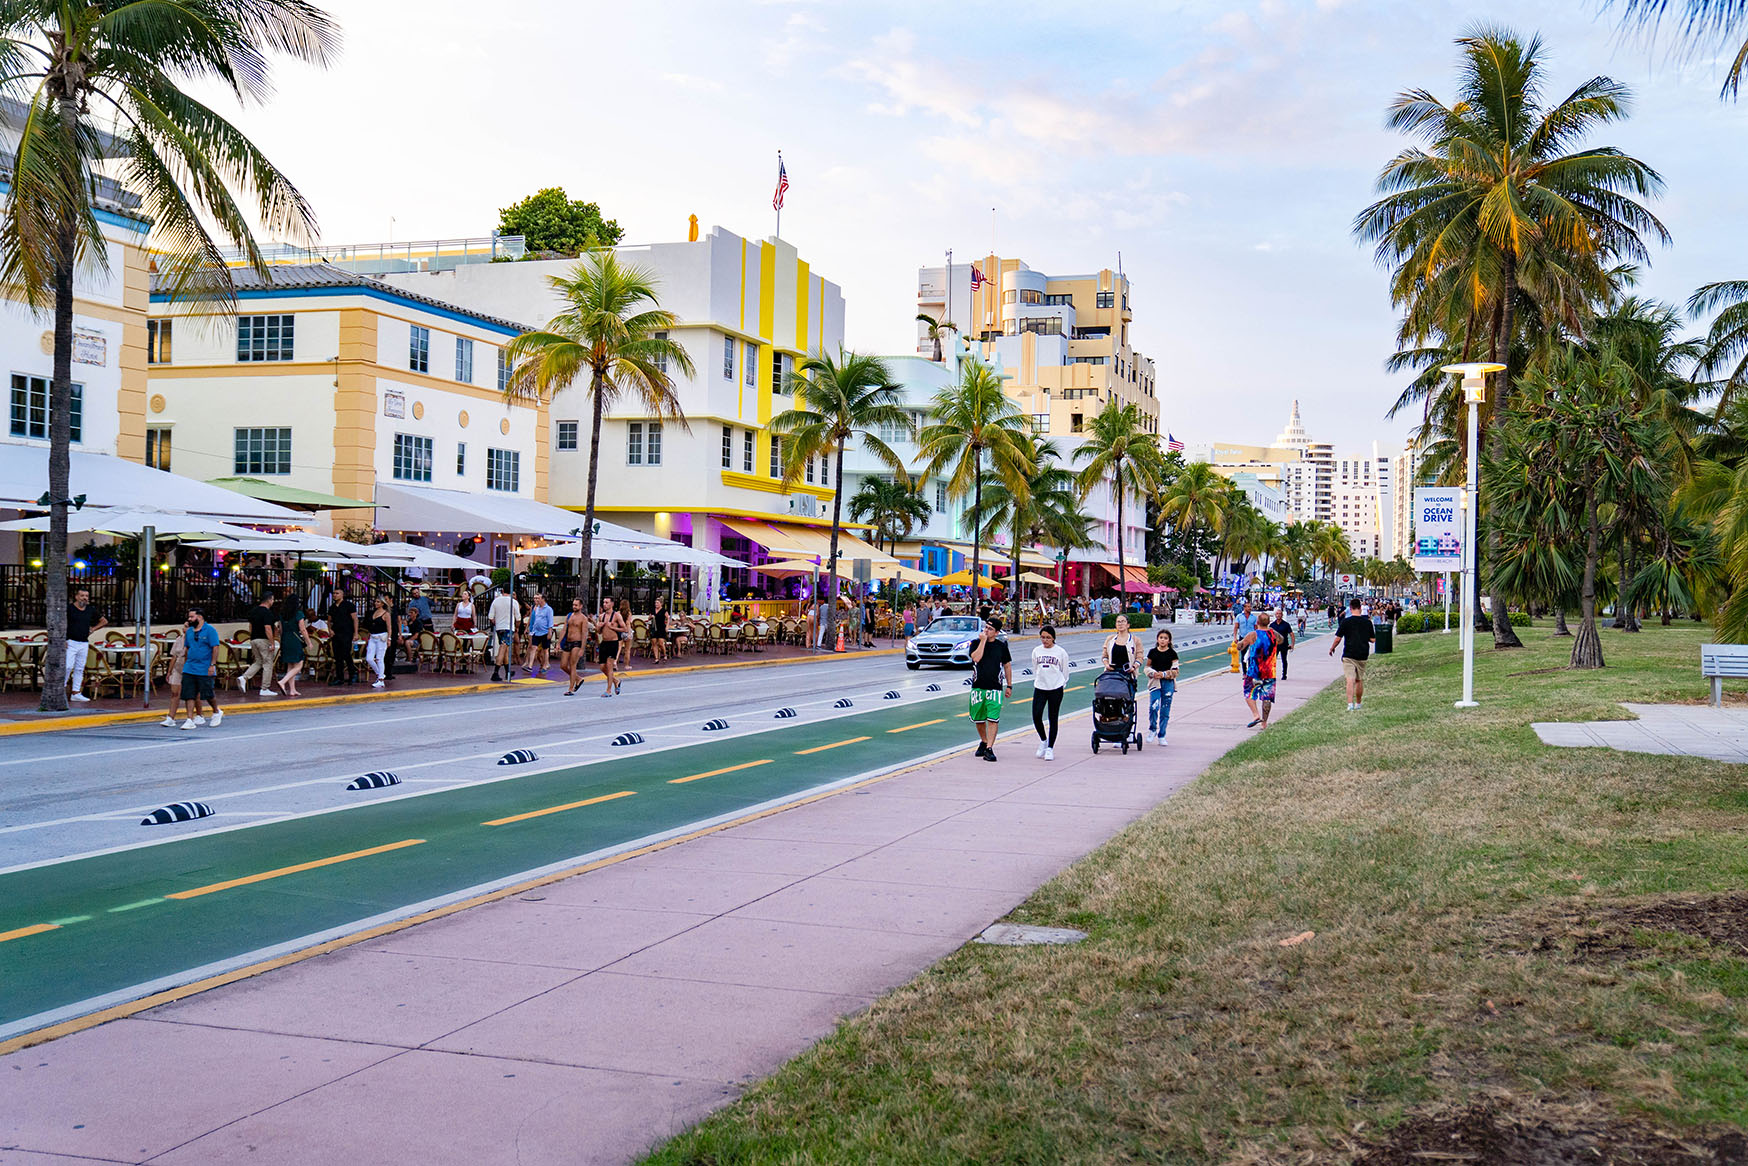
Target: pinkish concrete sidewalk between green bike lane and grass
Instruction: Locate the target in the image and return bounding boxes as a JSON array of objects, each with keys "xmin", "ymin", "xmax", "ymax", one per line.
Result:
[{"xmin": 0, "ymin": 653, "xmax": 1342, "ymax": 1166}]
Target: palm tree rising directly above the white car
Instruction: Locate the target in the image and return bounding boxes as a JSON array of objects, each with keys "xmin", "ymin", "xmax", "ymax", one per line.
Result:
[{"xmin": 916, "ymin": 360, "xmax": 1026, "ymax": 591}]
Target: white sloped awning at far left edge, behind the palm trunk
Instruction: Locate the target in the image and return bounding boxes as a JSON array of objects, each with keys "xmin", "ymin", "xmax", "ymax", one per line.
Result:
[{"xmin": 0, "ymin": 442, "xmax": 306, "ymax": 526}]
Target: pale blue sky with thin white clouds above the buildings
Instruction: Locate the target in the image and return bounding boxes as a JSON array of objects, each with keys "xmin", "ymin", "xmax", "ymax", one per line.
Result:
[{"xmin": 208, "ymin": 0, "xmax": 1748, "ymax": 451}]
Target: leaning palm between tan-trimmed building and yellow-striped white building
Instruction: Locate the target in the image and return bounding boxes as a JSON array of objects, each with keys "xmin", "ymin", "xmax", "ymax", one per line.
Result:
[{"xmin": 503, "ymin": 250, "xmax": 692, "ymax": 610}]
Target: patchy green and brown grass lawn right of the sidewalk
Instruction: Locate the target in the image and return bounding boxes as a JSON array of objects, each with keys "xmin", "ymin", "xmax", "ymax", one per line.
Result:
[{"xmin": 649, "ymin": 624, "xmax": 1748, "ymax": 1164}]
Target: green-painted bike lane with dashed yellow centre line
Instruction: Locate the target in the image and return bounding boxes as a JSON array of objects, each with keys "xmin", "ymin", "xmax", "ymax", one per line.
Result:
[{"xmin": 0, "ymin": 649, "xmax": 1258, "ymax": 1035}]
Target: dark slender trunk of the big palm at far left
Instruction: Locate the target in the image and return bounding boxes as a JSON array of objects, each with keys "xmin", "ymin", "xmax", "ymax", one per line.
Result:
[{"xmin": 38, "ymin": 184, "xmax": 78, "ymax": 713}]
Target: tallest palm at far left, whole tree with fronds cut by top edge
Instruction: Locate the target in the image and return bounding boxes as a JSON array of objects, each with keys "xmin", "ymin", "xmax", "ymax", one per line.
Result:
[{"xmin": 0, "ymin": 0, "xmax": 339, "ymax": 711}]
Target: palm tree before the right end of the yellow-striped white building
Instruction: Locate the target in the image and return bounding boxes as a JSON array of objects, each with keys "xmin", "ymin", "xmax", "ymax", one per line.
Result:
[{"xmin": 771, "ymin": 348, "xmax": 916, "ymax": 643}]
